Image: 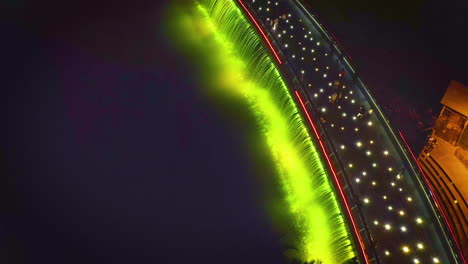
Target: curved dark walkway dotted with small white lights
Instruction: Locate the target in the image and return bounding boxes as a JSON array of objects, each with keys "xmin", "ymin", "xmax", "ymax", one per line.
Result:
[{"xmin": 237, "ymin": 0, "xmax": 466, "ymax": 264}]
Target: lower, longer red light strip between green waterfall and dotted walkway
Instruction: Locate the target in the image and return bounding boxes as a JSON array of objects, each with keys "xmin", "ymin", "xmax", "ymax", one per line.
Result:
[{"xmin": 295, "ymin": 90, "xmax": 369, "ymax": 264}]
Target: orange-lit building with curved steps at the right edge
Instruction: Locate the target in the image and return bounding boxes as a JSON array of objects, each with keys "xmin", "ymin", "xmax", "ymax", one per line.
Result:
[{"xmin": 419, "ymin": 81, "xmax": 468, "ymax": 256}]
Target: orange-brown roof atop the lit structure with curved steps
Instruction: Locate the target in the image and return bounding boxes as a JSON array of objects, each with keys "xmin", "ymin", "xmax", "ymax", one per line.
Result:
[{"xmin": 440, "ymin": 81, "xmax": 468, "ymax": 116}]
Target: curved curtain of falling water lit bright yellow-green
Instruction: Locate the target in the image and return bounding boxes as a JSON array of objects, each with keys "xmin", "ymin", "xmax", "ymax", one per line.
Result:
[{"xmin": 165, "ymin": 0, "xmax": 354, "ymax": 264}]
